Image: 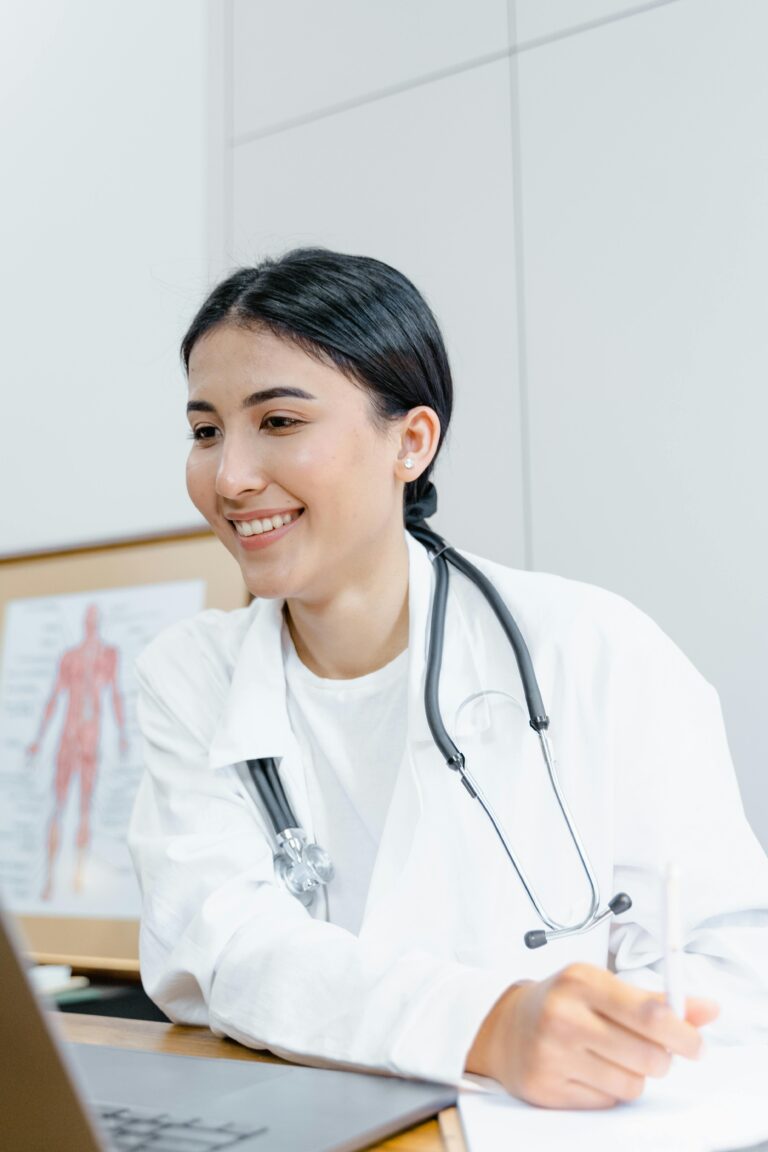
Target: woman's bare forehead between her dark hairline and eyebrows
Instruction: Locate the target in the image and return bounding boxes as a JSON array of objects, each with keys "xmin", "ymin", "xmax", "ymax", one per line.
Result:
[{"xmin": 188, "ymin": 324, "xmax": 360, "ymax": 399}]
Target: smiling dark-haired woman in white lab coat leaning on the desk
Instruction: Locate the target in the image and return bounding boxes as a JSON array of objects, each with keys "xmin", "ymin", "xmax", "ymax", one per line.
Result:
[{"xmin": 130, "ymin": 249, "xmax": 768, "ymax": 1108}]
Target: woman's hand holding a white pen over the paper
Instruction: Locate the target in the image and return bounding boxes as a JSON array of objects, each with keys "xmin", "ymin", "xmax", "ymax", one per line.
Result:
[{"xmin": 466, "ymin": 964, "xmax": 720, "ymax": 1108}]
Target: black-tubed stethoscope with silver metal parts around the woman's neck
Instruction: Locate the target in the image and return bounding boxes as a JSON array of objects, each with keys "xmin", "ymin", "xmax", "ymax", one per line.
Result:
[{"xmin": 246, "ymin": 484, "xmax": 632, "ymax": 948}]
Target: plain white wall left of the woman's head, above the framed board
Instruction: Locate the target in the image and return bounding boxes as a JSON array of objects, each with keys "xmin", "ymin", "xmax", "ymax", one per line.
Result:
[{"xmin": 0, "ymin": 0, "xmax": 207, "ymax": 554}]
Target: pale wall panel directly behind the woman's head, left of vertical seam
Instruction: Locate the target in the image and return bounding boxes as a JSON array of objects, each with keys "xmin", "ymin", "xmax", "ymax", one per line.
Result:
[{"xmin": 234, "ymin": 61, "xmax": 523, "ymax": 564}]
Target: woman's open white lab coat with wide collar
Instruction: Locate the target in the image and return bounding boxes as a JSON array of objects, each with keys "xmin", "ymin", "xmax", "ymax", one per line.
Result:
[{"xmin": 130, "ymin": 536, "xmax": 768, "ymax": 1082}]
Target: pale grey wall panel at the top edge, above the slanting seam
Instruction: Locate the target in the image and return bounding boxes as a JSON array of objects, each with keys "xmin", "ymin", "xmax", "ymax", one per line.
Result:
[{"xmin": 234, "ymin": 0, "xmax": 509, "ymax": 139}]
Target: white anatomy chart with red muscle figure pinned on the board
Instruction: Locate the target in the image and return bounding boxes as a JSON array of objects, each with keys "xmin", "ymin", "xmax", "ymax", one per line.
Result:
[{"xmin": 0, "ymin": 579, "xmax": 205, "ymax": 919}]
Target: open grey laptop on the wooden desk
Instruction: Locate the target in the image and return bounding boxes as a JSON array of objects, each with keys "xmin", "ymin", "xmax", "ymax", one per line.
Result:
[{"xmin": 0, "ymin": 909, "xmax": 456, "ymax": 1152}]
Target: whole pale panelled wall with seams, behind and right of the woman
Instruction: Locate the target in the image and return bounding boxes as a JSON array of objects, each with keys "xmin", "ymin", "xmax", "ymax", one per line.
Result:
[{"xmin": 216, "ymin": 0, "xmax": 768, "ymax": 843}]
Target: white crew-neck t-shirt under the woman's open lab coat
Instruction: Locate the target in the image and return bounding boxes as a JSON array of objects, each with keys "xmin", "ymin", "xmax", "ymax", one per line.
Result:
[{"xmin": 282, "ymin": 623, "xmax": 408, "ymax": 932}]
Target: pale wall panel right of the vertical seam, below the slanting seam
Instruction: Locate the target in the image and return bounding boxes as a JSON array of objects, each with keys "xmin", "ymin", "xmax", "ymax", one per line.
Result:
[{"xmin": 519, "ymin": 0, "xmax": 768, "ymax": 843}]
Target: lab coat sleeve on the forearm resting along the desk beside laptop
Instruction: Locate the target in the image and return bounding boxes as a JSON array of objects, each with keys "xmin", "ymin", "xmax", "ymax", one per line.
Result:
[{"xmin": 129, "ymin": 665, "xmax": 511, "ymax": 1083}]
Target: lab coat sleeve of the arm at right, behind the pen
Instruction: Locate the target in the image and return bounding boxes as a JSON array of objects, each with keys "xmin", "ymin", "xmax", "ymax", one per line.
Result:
[{"xmin": 610, "ymin": 614, "xmax": 768, "ymax": 1041}]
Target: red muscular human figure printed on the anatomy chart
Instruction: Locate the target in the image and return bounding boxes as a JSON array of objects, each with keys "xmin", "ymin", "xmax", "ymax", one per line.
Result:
[{"xmin": 28, "ymin": 604, "xmax": 127, "ymax": 900}]
